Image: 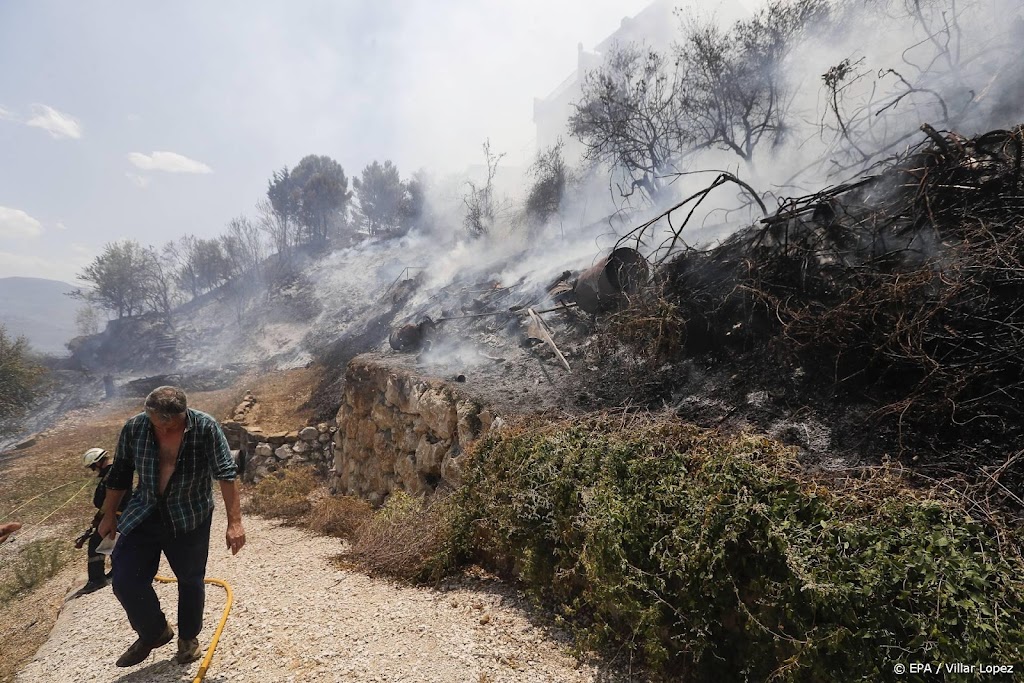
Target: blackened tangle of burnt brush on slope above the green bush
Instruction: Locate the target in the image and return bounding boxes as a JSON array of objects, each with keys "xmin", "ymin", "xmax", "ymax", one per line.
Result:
[{"xmin": 581, "ymin": 126, "xmax": 1024, "ymax": 481}]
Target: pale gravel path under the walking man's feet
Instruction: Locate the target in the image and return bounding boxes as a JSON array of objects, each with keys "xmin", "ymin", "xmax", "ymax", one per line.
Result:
[{"xmin": 16, "ymin": 506, "xmax": 638, "ymax": 683}]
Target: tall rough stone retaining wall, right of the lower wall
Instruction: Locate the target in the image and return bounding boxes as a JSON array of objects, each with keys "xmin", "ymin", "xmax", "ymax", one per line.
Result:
[{"xmin": 334, "ymin": 354, "xmax": 499, "ymax": 505}]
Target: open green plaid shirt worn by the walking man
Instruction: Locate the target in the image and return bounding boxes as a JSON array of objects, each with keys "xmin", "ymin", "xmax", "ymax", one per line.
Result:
[{"xmin": 106, "ymin": 409, "xmax": 237, "ymax": 536}]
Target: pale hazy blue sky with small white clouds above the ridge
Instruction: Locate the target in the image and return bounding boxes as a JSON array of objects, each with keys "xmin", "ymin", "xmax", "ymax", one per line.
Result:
[{"xmin": 6, "ymin": 0, "xmax": 720, "ymax": 282}]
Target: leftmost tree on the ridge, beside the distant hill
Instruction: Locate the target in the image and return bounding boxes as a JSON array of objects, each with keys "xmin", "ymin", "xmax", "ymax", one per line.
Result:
[{"xmin": 78, "ymin": 240, "xmax": 148, "ymax": 318}]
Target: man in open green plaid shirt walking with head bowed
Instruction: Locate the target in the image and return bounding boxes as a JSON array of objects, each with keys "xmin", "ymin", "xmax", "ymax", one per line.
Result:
[{"xmin": 99, "ymin": 386, "xmax": 246, "ymax": 667}]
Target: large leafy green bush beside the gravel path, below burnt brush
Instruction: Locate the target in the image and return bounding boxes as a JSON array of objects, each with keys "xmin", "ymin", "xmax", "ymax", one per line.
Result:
[{"xmin": 460, "ymin": 419, "xmax": 1024, "ymax": 681}]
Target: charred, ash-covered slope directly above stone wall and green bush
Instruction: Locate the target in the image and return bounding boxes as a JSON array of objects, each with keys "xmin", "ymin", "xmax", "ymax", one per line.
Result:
[{"xmin": 339, "ymin": 128, "xmax": 1024, "ymax": 501}]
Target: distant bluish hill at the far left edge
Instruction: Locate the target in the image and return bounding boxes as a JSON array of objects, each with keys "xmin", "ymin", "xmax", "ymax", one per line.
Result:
[{"xmin": 0, "ymin": 278, "xmax": 82, "ymax": 354}]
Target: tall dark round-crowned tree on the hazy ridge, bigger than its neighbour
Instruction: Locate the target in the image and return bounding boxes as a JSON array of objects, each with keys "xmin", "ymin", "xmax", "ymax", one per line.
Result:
[{"xmin": 288, "ymin": 155, "xmax": 352, "ymax": 243}]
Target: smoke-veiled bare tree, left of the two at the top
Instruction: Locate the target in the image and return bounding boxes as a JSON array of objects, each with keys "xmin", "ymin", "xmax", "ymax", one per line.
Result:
[{"xmin": 569, "ymin": 45, "xmax": 687, "ymax": 200}]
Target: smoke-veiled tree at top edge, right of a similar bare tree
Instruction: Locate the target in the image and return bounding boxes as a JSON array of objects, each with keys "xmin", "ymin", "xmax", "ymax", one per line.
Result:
[{"xmin": 674, "ymin": 0, "xmax": 828, "ymax": 164}]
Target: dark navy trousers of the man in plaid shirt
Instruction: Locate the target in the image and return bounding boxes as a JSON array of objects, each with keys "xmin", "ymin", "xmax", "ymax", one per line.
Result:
[{"xmin": 112, "ymin": 511, "xmax": 213, "ymax": 642}]
